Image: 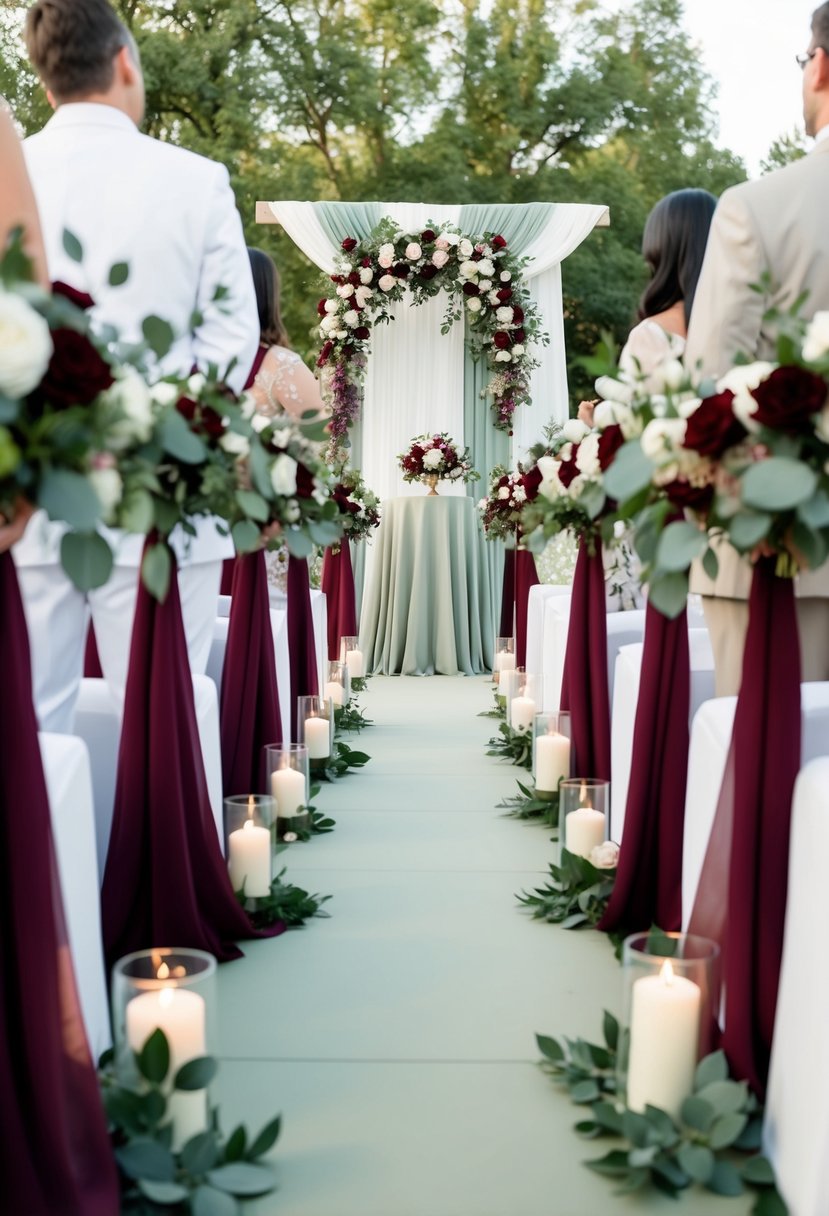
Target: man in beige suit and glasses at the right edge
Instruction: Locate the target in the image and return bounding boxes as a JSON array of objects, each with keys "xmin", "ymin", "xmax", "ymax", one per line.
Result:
[{"xmin": 686, "ymin": 2, "xmax": 829, "ymax": 696}]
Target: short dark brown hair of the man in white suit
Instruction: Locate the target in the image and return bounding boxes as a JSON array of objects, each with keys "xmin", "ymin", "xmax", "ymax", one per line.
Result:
[{"xmin": 26, "ymin": 0, "xmax": 135, "ymax": 103}]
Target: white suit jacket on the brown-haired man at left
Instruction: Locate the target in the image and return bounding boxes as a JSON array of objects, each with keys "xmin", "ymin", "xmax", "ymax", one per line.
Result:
[{"xmin": 15, "ymin": 102, "xmax": 259, "ymax": 565}]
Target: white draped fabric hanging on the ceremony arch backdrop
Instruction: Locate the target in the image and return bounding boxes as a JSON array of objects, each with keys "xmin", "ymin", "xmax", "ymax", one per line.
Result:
[{"xmin": 269, "ymin": 201, "xmax": 608, "ymax": 499}]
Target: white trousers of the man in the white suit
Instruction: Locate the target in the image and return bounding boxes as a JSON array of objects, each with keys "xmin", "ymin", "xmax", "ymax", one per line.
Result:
[{"xmin": 17, "ymin": 562, "xmax": 221, "ymax": 734}]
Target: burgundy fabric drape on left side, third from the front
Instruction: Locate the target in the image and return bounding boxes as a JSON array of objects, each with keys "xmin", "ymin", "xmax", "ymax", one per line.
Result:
[{"xmin": 220, "ymin": 550, "xmax": 282, "ymax": 796}]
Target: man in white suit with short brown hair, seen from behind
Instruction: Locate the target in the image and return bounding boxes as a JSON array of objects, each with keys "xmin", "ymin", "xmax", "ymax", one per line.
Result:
[{"xmin": 13, "ymin": 0, "xmax": 259, "ymax": 732}]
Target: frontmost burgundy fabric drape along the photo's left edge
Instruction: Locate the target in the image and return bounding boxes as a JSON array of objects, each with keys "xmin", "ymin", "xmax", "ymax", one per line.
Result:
[{"xmin": 0, "ymin": 553, "xmax": 120, "ymax": 1216}]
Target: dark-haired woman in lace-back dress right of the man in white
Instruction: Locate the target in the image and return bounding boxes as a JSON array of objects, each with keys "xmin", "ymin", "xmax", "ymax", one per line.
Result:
[{"xmin": 246, "ymin": 248, "xmax": 325, "ymax": 417}]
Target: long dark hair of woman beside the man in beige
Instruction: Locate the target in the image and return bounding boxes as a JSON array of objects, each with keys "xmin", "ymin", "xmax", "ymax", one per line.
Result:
[{"xmin": 638, "ymin": 190, "xmax": 717, "ymax": 323}]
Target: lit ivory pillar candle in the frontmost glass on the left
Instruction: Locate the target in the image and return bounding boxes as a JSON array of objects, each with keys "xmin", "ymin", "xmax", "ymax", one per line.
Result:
[{"xmin": 125, "ymin": 963, "xmax": 208, "ymax": 1152}]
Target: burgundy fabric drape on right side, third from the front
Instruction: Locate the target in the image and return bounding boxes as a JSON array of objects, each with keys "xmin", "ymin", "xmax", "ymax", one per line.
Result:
[{"xmin": 559, "ymin": 540, "xmax": 610, "ymax": 781}]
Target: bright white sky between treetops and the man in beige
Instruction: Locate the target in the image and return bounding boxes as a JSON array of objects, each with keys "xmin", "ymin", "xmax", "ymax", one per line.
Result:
[{"xmin": 666, "ymin": 0, "xmax": 819, "ymax": 176}]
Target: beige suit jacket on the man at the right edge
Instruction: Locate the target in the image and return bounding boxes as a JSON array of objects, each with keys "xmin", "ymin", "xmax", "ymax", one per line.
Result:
[{"xmin": 686, "ymin": 140, "xmax": 829, "ymax": 599}]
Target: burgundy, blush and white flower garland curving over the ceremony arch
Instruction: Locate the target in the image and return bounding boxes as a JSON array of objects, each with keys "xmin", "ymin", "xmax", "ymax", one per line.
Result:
[{"xmin": 317, "ymin": 219, "xmax": 549, "ymax": 450}]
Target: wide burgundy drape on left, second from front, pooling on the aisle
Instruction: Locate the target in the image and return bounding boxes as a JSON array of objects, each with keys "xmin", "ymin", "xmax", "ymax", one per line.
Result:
[{"xmin": 101, "ymin": 542, "xmax": 284, "ymax": 966}]
